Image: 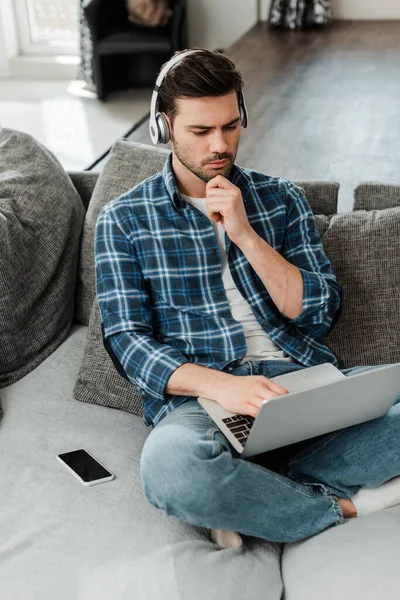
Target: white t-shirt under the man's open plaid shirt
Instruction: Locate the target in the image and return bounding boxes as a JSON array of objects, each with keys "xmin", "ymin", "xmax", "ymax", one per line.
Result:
[{"xmin": 181, "ymin": 194, "xmax": 293, "ymax": 364}]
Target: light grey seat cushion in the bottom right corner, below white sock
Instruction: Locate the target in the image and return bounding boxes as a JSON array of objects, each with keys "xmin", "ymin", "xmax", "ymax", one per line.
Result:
[{"xmin": 282, "ymin": 506, "xmax": 400, "ymax": 600}]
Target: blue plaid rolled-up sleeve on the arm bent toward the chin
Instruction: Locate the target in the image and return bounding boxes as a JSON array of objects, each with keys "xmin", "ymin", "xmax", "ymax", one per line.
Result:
[{"xmin": 282, "ymin": 183, "xmax": 342, "ymax": 338}]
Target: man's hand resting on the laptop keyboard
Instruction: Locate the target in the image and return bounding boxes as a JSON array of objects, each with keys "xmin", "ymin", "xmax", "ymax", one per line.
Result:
[{"xmin": 212, "ymin": 375, "xmax": 289, "ymax": 418}]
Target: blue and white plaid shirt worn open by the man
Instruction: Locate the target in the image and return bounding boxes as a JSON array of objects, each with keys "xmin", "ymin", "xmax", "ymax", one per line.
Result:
[{"xmin": 95, "ymin": 153, "xmax": 341, "ymax": 426}]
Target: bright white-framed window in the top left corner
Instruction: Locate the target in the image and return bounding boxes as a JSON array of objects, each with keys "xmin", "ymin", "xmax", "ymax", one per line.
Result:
[{"xmin": 15, "ymin": 0, "xmax": 78, "ymax": 54}]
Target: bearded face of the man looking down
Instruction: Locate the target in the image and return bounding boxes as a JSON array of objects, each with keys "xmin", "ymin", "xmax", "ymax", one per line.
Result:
[{"xmin": 166, "ymin": 92, "xmax": 240, "ymax": 183}]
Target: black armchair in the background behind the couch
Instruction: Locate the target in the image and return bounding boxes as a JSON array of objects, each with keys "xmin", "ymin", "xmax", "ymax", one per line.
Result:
[{"xmin": 82, "ymin": 0, "xmax": 188, "ymax": 100}]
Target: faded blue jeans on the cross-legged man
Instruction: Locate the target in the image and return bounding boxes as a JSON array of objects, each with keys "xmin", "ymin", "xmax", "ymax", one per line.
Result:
[{"xmin": 140, "ymin": 360, "xmax": 400, "ymax": 543}]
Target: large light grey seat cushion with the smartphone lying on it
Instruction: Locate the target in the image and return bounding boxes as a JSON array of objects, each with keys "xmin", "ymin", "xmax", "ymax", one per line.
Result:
[{"xmin": 0, "ymin": 325, "xmax": 283, "ymax": 600}]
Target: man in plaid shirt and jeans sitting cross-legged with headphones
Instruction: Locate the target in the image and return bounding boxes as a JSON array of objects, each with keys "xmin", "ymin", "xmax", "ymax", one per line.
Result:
[{"xmin": 95, "ymin": 49, "xmax": 400, "ymax": 547}]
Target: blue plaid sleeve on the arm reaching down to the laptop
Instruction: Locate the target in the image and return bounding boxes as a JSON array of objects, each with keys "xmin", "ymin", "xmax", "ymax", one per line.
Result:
[{"xmin": 94, "ymin": 207, "xmax": 189, "ymax": 400}]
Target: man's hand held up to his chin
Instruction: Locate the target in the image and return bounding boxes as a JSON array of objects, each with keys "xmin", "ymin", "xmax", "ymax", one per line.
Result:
[{"xmin": 206, "ymin": 175, "xmax": 254, "ymax": 246}]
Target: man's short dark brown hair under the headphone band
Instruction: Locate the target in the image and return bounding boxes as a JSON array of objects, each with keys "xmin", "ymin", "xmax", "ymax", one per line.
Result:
[{"xmin": 158, "ymin": 48, "xmax": 244, "ymax": 124}]
